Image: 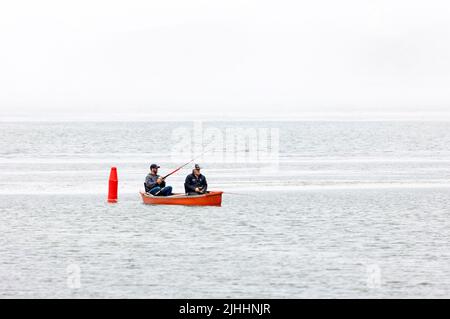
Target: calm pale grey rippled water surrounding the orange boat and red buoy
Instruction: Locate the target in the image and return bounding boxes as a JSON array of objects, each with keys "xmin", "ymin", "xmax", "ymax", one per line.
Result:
[{"xmin": 0, "ymin": 121, "xmax": 450, "ymax": 298}]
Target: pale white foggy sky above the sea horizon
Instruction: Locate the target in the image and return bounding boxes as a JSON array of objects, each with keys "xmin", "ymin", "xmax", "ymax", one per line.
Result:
[{"xmin": 0, "ymin": 0, "xmax": 450, "ymax": 116}]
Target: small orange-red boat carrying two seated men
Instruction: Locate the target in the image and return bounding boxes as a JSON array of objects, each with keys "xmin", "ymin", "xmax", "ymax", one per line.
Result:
[{"xmin": 140, "ymin": 191, "xmax": 223, "ymax": 206}]
